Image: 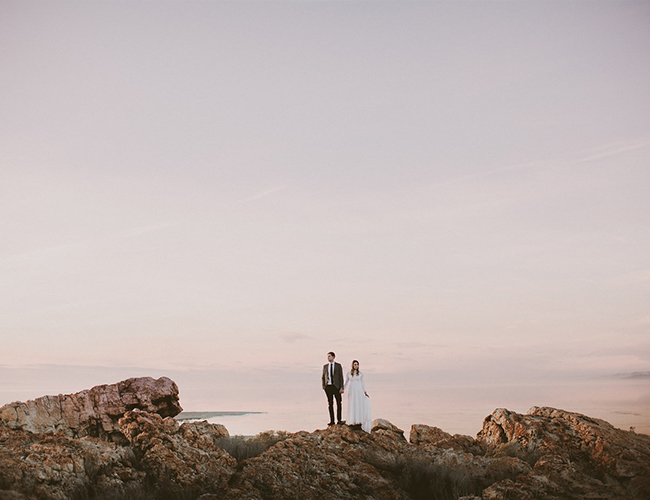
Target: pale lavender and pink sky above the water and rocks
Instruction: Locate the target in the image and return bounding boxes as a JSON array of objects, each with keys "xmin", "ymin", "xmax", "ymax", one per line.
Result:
[{"xmin": 0, "ymin": 0, "xmax": 650, "ymax": 434}]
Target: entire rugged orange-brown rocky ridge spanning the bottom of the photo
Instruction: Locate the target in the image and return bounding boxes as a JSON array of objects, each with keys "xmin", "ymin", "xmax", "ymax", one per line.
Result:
[{"xmin": 0, "ymin": 379, "xmax": 650, "ymax": 500}]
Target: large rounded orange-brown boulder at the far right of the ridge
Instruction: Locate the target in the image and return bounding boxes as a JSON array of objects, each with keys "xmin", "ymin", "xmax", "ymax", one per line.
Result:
[{"xmin": 470, "ymin": 407, "xmax": 650, "ymax": 500}]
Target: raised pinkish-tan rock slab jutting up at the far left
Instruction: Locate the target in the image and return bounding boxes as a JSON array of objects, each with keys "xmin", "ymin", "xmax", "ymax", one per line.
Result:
[{"xmin": 0, "ymin": 377, "xmax": 183, "ymax": 442}]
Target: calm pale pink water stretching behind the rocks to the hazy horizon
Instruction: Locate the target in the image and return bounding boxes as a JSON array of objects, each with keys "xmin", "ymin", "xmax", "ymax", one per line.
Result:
[{"xmin": 0, "ymin": 365, "xmax": 650, "ymax": 436}]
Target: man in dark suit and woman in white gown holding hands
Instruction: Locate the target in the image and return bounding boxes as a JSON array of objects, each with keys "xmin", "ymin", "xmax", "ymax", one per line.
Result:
[{"xmin": 323, "ymin": 352, "xmax": 372, "ymax": 432}]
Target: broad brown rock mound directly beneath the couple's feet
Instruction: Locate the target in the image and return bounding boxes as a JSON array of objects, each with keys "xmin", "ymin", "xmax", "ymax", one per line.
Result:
[{"xmin": 223, "ymin": 424, "xmax": 410, "ymax": 500}]
